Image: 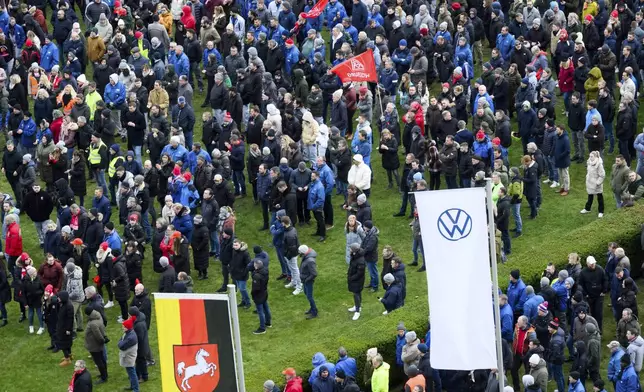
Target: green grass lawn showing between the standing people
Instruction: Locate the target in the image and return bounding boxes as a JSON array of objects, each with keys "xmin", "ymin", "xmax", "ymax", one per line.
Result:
[{"xmin": 0, "ymin": 29, "xmax": 644, "ymax": 392}]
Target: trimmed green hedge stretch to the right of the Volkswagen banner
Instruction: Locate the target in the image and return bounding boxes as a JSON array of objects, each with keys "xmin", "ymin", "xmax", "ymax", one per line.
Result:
[{"xmin": 499, "ymin": 204, "xmax": 644, "ymax": 290}]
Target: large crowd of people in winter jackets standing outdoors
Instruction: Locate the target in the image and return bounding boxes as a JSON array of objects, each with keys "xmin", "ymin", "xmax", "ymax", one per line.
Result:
[{"xmin": 0, "ymin": 0, "xmax": 644, "ymax": 392}]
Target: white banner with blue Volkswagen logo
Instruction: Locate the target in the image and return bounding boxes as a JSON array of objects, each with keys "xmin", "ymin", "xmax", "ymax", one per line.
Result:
[{"xmin": 414, "ymin": 188, "xmax": 497, "ymax": 370}]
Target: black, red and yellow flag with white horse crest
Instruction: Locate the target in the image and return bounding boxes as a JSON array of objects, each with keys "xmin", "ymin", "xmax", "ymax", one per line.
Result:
[{"xmin": 155, "ymin": 294, "xmax": 238, "ymax": 392}]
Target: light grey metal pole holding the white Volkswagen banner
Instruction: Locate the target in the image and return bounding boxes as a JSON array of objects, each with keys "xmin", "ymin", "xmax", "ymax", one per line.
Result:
[{"xmin": 485, "ymin": 178, "xmax": 505, "ymax": 392}]
